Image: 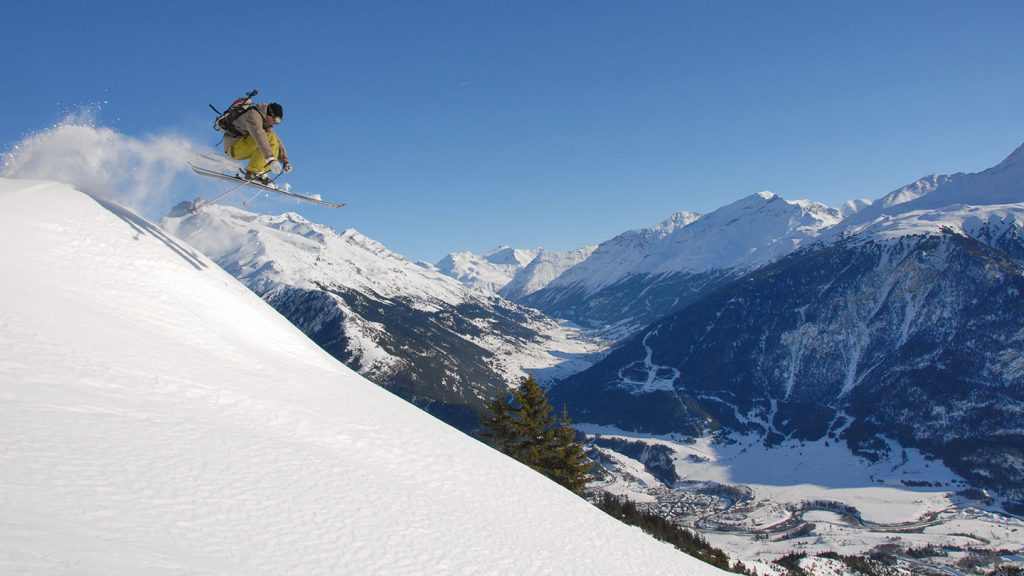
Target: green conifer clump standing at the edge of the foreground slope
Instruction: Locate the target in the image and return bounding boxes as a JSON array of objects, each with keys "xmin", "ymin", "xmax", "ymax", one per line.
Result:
[{"xmin": 480, "ymin": 376, "xmax": 591, "ymax": 494}]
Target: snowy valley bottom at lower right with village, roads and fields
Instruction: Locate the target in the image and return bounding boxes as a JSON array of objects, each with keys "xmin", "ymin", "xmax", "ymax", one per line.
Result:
[{"xmin": 583, "ymin": 426, "xmax": 1024, "ymax": 574}]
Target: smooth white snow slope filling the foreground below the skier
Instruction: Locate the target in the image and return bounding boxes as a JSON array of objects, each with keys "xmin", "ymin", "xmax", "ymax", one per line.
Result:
[{"xmin": 0, "ymin": 179, "xmax": 718, "ymax": 575}]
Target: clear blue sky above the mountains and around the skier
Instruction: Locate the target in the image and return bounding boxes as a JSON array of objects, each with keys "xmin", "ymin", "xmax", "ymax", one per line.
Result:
[{"xmin": 6, "ymin": 0, "xmax": 1024, "ymax": 261}]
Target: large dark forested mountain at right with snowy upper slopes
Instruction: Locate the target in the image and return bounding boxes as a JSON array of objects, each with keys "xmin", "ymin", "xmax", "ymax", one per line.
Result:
[{"xmin": 551, "ymin": 142, "xmax": 1024, "ymax": 499}]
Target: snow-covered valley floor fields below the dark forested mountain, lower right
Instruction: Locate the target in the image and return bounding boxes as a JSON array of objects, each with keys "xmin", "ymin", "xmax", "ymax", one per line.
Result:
[{"xmin": 580, "ymin": 425, "xmax": 1024, "ymax": 566}]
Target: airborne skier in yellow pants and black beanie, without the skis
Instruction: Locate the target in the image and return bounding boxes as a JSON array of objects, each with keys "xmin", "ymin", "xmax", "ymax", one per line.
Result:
[{"xmin": 224, "ymin": 102, "xmax": 292, "ymax": 184}]
